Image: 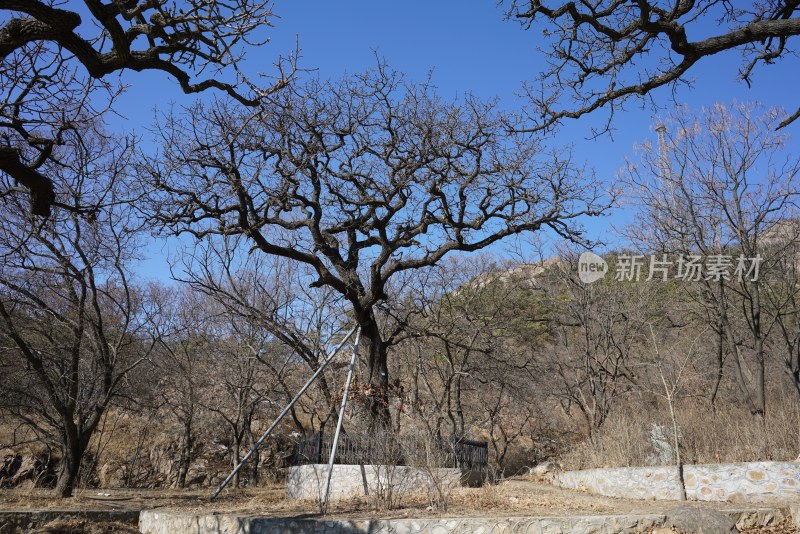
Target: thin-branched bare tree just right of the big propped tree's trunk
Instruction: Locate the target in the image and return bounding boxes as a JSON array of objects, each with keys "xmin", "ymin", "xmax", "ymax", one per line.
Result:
[{"xmin": 395, "ymin": 254, "xmax": 548, "ymax": 438}]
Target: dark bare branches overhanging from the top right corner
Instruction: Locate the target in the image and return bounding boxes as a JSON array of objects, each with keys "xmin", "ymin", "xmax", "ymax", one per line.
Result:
[{"xmin": 505, "ymin": 0, "xmax": 800, "ymax": 130}]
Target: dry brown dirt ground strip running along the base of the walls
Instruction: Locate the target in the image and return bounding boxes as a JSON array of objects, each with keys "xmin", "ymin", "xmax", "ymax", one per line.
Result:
[{"xmin": 0, "ymin": 479, "xmax": 797, "ymax": 534}]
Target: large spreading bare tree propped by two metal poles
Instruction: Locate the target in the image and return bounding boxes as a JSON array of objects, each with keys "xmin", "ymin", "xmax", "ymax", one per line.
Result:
[{"xmin": 142, "ymin": 65, "xmax": 606, "ymax": 432}]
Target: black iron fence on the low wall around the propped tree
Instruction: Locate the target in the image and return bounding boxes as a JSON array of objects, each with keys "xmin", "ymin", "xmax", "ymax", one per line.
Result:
[{"xmin": 295, "ymin": 432, "xmax": 489, "ymax": 469}]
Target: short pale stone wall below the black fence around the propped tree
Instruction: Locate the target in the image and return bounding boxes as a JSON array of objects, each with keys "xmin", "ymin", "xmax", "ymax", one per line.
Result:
[{"xmin": 286, "ymin": 464, "xmax": 461, "ymax": 500}]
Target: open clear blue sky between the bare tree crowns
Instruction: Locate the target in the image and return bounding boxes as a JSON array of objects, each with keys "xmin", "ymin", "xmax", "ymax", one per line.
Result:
[{"xmin": 115, "ymin": 0, "xmax": 800, "ymax": 278}]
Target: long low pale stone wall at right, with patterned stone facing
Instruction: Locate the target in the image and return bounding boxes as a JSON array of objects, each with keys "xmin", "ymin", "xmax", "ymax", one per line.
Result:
[{"xmin": 551, "ymin": 462, "xmax": 800, "ymax": 502}]
